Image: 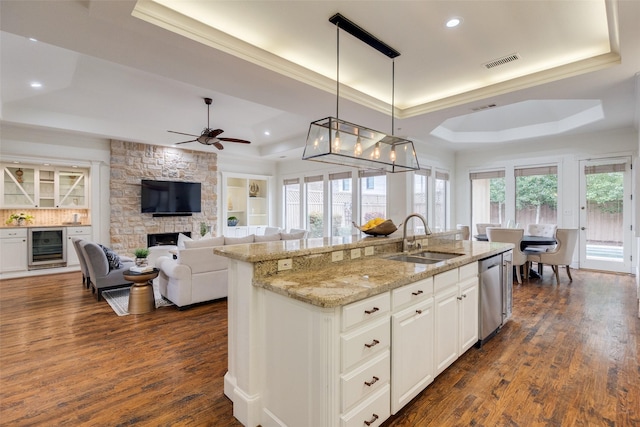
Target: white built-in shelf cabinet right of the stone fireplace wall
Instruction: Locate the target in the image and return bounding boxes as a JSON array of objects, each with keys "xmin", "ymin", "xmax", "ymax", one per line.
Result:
[{"xmin": 222, "ymin": 173, "xmax": 271, "ymax": 237}]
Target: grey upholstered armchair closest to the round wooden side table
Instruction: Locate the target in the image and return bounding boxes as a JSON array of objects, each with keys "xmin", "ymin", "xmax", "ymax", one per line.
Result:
[{"xmin": 80, "ymin": 240, "xmax": 135, "ymax": 301}]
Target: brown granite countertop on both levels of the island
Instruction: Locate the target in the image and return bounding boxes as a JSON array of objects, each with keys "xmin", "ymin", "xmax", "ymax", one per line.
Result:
[{"xmin": 216, "ymin": 239, "xmax": 513, "ymax": 308}]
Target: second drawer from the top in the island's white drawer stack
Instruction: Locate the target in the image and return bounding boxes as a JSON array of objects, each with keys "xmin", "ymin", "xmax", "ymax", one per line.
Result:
[{"xmin": 341, "ymin": 316, "xmax": 391, "ymax": 372}]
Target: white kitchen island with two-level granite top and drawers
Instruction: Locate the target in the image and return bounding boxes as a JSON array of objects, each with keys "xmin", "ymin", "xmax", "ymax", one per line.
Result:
[{"xmin": 215, "ymin": 231, "xmax": 513, "ymax": 426}]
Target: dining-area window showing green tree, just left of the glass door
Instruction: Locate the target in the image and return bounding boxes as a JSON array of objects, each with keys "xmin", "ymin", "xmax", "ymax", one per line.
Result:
[{"xmin": 514, "ymin": 166, "xmax": 558, "ymax": 227}]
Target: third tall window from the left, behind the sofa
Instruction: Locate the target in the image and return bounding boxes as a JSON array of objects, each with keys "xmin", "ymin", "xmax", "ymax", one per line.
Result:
[{"xmin": 329, "ymin": 172, "xmax": 353, "ymax": 237}]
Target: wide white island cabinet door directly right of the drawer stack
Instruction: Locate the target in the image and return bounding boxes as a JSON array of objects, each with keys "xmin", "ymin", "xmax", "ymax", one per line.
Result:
[{"xmin": 391, "ymin": 298, "xmax": 434, "ymax": 414}]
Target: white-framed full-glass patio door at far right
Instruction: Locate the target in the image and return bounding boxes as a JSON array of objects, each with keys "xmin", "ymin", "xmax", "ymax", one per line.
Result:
[{"xmin": 579, "ymin": 157, "xmax": 632, "ymax": 273}]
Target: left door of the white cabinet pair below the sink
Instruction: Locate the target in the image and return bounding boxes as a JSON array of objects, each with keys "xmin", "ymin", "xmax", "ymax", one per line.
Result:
[{"xmin": 434, "ymin": 285, "xmax": 460, "ymax": 375}]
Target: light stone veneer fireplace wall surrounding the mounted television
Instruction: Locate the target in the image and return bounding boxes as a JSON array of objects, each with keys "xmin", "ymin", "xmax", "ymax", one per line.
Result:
[{"xmin": 109, "ymin": 141, "xmax": 218, "ymax": 255}]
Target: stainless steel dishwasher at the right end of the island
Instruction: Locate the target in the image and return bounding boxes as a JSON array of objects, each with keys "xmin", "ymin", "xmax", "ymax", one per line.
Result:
[{"xmin": 478, "ymin": 254, "xmax": 505, "ymax": 347}]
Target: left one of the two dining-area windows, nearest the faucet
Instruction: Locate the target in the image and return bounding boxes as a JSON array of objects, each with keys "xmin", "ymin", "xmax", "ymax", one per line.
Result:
[{"xmin": 469, "ymin": 170, "xmax": 506, "ymax": 233}]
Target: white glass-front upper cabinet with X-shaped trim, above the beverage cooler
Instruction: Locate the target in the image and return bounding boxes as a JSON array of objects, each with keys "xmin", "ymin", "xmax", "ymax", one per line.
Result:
[{"xmin": 0, "ymin": 165, "xmax": 89, "ymax": 209}]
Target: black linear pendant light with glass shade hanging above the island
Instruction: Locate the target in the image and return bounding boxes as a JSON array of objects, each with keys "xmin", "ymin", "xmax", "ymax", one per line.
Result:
[{"xmin": 302, "ymin": 13, "xmax": 420, "ymax": 172}]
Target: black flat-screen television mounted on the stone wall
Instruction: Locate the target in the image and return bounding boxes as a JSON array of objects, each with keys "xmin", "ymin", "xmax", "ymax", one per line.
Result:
[{"xmin": 140, "ymin": 179, "xmax": 202, "ymax": 216}]
